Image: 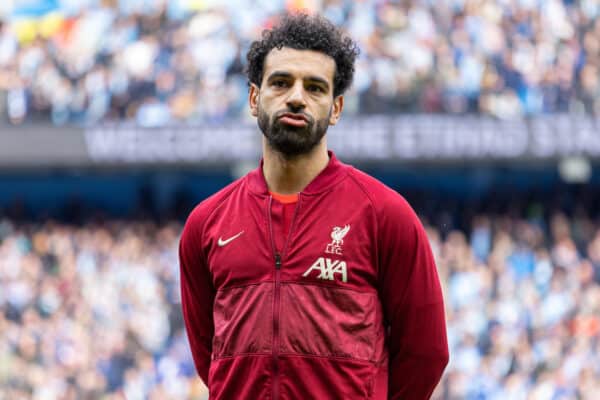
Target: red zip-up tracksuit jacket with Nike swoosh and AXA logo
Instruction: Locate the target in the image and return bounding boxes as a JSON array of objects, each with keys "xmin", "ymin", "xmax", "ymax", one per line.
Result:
[{"xmin": 179, "ymin": 153, "xmax": 448, "ymax": 400}]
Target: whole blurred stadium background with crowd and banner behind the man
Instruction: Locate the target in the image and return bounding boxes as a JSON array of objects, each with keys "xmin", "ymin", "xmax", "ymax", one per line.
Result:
[{"xmin": 0, "ymin": 0, "xmax": 600, "ymax": 400}]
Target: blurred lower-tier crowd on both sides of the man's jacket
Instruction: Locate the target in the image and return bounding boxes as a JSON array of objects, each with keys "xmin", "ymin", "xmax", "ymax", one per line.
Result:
[{"xmin": 0, "ymin": 206, "xmax": 600, "ymax": 400}]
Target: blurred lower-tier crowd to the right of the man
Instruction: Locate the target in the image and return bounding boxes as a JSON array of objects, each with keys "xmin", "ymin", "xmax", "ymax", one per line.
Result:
[{"xmin": 429, "ymin": 214, "xmax": 600, "ymax": 400}]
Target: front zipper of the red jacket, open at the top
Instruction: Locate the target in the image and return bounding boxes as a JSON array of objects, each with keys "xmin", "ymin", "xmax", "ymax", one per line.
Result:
[{"xmin": 268, "ymin": 195, "xmax": 300, "ymax": 400}]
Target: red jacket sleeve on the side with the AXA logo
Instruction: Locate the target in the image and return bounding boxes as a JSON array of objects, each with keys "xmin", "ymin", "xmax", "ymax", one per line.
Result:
[{"xmin": 378, "ymin": 195, "xmax": 449, "ymax": 399}]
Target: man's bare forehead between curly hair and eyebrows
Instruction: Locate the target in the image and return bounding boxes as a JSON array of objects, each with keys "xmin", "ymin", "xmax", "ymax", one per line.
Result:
[{"xmin": 263, "ymin": 47, "xmax": 335, "ymax": 83}]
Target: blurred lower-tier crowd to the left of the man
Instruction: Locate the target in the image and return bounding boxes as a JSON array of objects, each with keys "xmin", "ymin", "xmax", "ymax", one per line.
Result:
[{"xmin": 0, "ymin": 220, "xmax": 207, "ymax": 400}]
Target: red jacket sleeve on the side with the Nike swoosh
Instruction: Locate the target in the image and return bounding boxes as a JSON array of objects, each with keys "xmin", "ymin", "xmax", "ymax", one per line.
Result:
[{"xmin": 179, "ymin": 210, "xmax": 214, "ymax": 386}]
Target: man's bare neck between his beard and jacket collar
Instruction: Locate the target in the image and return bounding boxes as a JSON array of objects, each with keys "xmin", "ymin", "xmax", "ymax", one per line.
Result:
[{"xmin": 263, "ymin": 138, "xmax": 329, "ymax": 194}]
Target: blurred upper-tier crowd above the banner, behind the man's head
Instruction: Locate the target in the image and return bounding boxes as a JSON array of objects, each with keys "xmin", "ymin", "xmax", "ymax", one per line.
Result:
[{"xmin": 0, "ymin": 0, "xmax": 600, "ymax": 126}]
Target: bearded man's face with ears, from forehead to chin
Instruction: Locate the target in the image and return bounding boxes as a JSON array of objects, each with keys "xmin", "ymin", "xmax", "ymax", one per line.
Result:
[{"xmin": 249, "ymin": 47, "xmax": 344, "ymax": 157}]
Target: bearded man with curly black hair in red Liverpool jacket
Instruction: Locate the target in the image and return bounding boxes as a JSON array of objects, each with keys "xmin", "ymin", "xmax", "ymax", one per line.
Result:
[{"xmin": 180, "ymin": 14, "xmax": 448, "ymax": 399}]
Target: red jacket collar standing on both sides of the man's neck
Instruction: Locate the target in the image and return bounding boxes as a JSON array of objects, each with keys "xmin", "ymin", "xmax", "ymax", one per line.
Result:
[{"xmin": 246, "ymin": 150, "xmax": 350, "ymax": 196}]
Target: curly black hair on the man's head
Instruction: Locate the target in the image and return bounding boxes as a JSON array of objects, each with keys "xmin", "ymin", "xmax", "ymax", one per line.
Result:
[{"xmin": 246, "ymin": 13, "xmax": 359, "ymax": 97}]
